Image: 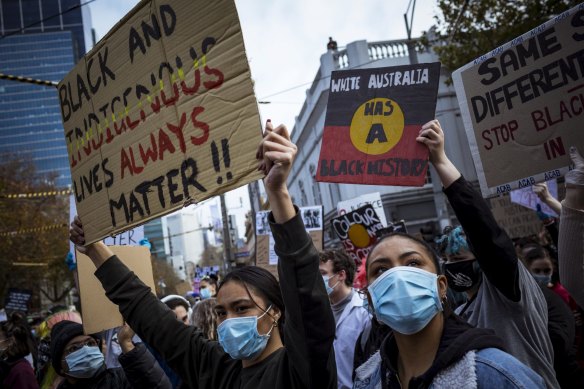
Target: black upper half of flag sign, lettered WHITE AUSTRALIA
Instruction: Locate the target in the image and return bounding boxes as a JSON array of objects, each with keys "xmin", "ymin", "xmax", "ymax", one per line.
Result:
[{"xmin": 325, "ymin": 62, "xmax": 440, "ymax": 126}]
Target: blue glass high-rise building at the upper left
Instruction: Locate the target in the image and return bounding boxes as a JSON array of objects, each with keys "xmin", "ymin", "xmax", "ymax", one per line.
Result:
[{"xmin": 0, "ymin": 0, "xmax": 92, "ymax": 188}]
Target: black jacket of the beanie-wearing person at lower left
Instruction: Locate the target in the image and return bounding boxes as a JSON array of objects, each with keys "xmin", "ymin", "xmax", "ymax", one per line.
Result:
[{"xmin": 59, "ymin": 343, "xmax": 172, "ymax": 389}]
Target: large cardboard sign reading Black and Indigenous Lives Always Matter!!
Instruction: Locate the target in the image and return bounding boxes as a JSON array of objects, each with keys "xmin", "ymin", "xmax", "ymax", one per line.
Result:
[{"xmin": 58, "ymin": 0, "xmax": 261, "ymax": 243}]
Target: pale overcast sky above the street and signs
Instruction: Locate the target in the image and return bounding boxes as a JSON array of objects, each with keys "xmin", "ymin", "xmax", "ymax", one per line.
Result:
[{"xmin": 89, "ymin": 0, "xmax": 436, "ymax": 129}]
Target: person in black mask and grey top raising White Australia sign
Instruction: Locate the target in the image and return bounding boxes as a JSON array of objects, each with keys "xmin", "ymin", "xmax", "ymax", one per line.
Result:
[{"xmin": 426, "ymin": 120, "xmax": 560, "ymax": 388}]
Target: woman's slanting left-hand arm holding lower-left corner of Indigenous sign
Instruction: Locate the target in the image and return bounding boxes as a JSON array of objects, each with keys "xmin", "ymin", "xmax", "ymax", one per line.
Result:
[{"xmin": 70, "ymin": 217, "xmax": 241, "ymax": 388}]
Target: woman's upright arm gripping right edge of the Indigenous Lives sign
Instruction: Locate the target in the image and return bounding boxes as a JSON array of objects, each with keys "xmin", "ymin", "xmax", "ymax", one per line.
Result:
[{"xmin": 258, "ymin": 123, "xmax": 337, "ymax": 388}]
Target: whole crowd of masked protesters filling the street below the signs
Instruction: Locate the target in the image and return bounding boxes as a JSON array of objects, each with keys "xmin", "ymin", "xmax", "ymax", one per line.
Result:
[{"xmin": 0, "ymin": 120, "xmax": 584, "ymax": 389}]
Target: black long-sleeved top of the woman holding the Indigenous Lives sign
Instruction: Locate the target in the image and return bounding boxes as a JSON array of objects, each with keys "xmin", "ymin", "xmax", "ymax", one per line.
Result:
[{"xmin": 95, "ymin": 211, "xmax": 337, "ymax": 389}]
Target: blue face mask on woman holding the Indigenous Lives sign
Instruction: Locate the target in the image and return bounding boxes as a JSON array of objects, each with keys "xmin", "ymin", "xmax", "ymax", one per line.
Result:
[{"xmin": 217, "ymin": 305, "xmax": 276, "ymax": 359}]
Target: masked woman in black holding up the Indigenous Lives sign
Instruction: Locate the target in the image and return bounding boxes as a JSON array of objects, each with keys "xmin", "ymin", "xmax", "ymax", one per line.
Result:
[{"xmin": 70, "ymin": 121, "xmax": 337, "ymax": 389}]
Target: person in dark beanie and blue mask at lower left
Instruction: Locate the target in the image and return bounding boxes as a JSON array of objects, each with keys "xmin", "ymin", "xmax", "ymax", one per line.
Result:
[{"xmin": 51, "ymin": 320, "xmax": 171, "ymax": 389}]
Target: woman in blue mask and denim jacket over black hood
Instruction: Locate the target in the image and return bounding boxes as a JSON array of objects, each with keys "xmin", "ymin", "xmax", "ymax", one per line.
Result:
[{"xmin": 354, "ymin": 226, "xmax": 545, "ymax": 389}]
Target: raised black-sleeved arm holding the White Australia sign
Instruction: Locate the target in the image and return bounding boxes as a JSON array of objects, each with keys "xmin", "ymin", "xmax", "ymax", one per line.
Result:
[{"xmin": 417, "ymin": 120, "xmax": 521, "ymax": 301}]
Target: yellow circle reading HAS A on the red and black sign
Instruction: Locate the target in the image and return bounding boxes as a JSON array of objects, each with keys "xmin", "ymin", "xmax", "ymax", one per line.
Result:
[{"xmin": 350, "ymin": 97, "xmax": 405, "ymax": 155}]
